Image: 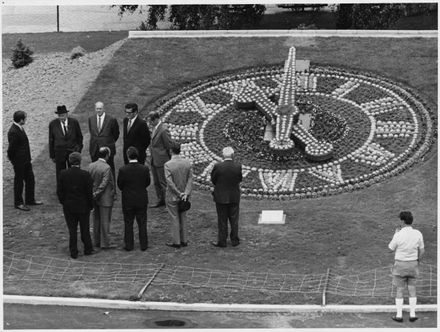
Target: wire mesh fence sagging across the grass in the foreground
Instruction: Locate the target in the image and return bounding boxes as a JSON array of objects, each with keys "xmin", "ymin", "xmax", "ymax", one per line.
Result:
[{"xmin": 3, "ymin": 250, "xmax": 437, "ymax": 298}]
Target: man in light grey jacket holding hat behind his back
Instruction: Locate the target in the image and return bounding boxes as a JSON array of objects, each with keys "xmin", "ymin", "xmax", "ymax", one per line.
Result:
[{"xmin": 164, "ymin": 143, "xmax": 192, "ymax": 248}]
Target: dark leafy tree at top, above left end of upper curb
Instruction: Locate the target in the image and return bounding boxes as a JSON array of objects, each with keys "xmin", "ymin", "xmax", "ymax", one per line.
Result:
[{"xmin": 113, "ymin": 5, "xmax": 266, "ymax": 30}]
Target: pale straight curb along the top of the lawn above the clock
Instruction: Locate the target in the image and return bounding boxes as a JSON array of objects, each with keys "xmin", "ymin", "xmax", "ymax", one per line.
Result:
[{"xmin": 128, "ymin": 29, "xmax": 438, "ymax": 38}]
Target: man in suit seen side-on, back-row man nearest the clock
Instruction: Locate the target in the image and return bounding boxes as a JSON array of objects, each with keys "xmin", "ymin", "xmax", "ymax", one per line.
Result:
[{"xmin": 148, "ymin": 112, "xmax": 173, "ymax": 208}]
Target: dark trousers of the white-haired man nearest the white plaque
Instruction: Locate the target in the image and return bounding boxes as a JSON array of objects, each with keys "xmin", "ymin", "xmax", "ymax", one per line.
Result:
[{"xmin": 215, "ymin": 203, "xmax": 240, "ymax": 246}]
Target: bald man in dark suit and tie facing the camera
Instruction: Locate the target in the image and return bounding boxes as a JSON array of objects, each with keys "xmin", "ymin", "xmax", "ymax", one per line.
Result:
[{"xmin": 89, "ymin": 101, "xmax": 119, "ymax": 176}]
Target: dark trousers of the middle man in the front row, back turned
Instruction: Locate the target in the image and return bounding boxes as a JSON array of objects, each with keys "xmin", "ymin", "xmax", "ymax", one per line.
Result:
[{"xmin": 122, "ymin": 207, "xmax": 148, "ymax": 250}]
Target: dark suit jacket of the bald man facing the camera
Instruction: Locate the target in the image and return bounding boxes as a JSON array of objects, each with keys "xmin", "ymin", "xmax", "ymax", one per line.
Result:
[{"xmin": 89, "ymin": 114, "xmax": 119, "ymax": 156}]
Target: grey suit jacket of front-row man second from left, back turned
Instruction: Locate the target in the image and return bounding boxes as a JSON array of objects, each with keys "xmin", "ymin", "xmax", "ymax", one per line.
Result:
[{"xmin": 89, "ymin": 159, "xmax": 116, "ymax": 206}]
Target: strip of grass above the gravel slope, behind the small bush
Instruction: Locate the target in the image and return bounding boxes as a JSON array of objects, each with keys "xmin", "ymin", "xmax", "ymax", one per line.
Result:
[{"xmin": 2, "ymin": 31, "xmax": 128, "ymax": 58}]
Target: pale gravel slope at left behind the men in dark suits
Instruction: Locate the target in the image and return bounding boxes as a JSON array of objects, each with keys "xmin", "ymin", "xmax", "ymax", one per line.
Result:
[{"xmin": 2, "ymin": 39, "xmax": 125, "ymax": 187}]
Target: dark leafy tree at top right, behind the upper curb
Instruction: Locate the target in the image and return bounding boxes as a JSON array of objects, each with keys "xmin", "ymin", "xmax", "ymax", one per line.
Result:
[{"xmin": 336, "ymin": 3, "xmax": 405, "ymax": 29}]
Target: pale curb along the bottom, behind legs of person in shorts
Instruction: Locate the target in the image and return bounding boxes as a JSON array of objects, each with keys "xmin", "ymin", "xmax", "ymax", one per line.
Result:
[{"xmin": 3, "ymin": 295, "xmax": 437, "ymax": 313}]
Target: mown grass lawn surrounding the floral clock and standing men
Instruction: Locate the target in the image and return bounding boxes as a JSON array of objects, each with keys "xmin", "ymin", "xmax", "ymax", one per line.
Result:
[{"xmin": 3, "ymin": 36, "xmax": 437, "ymax": 304}]
